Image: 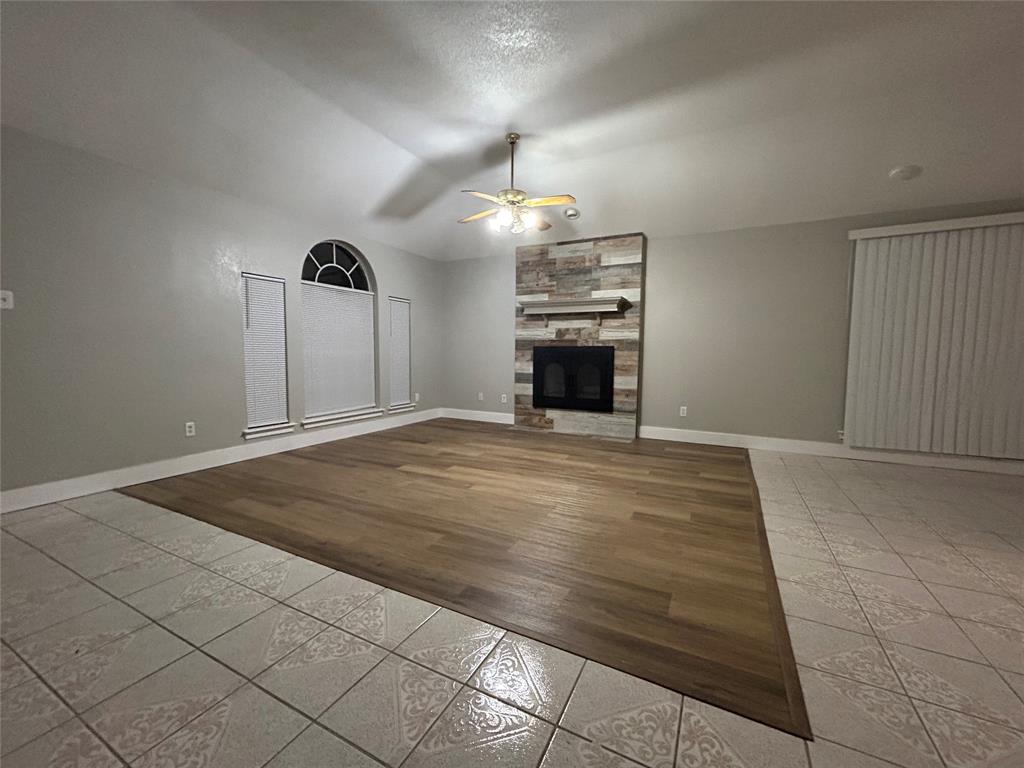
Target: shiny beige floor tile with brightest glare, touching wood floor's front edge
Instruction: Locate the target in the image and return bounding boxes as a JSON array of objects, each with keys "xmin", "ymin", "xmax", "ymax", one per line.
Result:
[{"xmin": 469, "ymin": 633, "xmax": 584, "ymax": 723}]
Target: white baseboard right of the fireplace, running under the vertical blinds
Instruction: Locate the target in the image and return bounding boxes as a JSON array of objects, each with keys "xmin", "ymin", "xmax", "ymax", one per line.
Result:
[{"xmin": 640, "ymin": 426, "xmax": 1024, "ymax": 475}]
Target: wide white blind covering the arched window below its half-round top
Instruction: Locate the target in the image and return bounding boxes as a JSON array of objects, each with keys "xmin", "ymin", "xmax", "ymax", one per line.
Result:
[{"xmin": 302, "ymin": 283, "xmax": 377, "ymax": 419}]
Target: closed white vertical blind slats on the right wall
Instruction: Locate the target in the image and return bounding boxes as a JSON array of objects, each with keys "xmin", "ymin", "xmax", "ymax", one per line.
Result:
[{"xmin": 845, "ymin": 218, "xmax": 1024, "ymax": 459}]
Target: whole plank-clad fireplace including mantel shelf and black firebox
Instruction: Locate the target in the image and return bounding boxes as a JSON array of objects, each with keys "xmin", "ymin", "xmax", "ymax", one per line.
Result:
[{"xmin": 515, "ymin": 233, "xmax": 647, "ymax": 438}]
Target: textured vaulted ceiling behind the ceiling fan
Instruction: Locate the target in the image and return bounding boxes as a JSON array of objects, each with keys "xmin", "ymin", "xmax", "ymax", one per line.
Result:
[{"xmin": 2, "ymin": 2, "xmax": 1024, "ymax": 258}]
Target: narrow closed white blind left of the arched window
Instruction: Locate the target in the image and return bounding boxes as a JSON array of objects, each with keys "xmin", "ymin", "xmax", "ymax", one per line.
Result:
[{"xmin": 242, "ymin": 273, "xmax": 288, "ymax": 429}]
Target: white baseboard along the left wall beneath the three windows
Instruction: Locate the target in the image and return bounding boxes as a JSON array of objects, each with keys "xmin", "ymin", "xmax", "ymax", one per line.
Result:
[{"xmin": 0, "ymin": 408, "xmax": 444, "ymax": 512}]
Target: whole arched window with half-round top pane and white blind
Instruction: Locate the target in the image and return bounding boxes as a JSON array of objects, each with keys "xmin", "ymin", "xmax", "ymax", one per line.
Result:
[{"xmin": 302, "ymin": 241, "xmax": 381, "ymax": 427}]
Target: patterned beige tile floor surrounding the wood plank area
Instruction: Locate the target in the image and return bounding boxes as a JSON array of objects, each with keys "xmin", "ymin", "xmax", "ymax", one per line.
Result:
[{"xmin": 0, "ymin": 452, "xmax": 1024, "ymax": 768}]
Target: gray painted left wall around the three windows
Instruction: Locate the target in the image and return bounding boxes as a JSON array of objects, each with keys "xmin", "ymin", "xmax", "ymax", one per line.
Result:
[{"xmin": 0, "ymin": 128, "xmax": 444, "ymax": 488}]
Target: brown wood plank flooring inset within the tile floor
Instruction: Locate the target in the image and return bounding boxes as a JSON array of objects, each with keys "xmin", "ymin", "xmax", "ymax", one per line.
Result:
[{"xmin": 123, "ymin": 419, "xmax": 810, "ymax": 737}]
